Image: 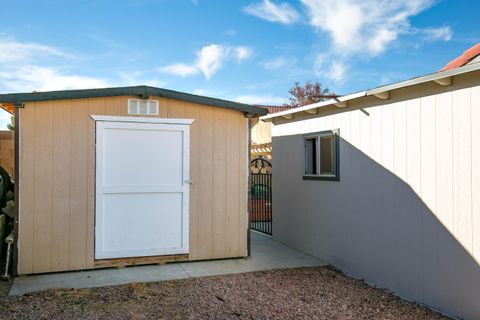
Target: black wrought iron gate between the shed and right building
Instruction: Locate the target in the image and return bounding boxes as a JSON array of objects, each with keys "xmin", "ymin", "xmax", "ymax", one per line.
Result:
[{"xmin": 248, "ymin": 158, "xmax": 272, "ymax": 235}]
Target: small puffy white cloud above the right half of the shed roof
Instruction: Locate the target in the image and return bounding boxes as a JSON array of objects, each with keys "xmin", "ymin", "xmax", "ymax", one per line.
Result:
[{"xmin": 158, "ymin": 44, "xmax": 252, "ymax": 79}]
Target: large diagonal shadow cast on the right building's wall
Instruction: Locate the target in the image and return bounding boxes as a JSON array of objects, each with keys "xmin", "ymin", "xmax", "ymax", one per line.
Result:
[{"xmin": 273, "ymin": 135, "xmax": 480, "ymax": 319}]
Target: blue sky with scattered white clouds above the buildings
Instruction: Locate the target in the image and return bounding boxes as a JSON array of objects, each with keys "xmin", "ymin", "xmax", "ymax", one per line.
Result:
[{"xmin": 0, "ymin": 0, "xmax": 480, "ymax": 125}]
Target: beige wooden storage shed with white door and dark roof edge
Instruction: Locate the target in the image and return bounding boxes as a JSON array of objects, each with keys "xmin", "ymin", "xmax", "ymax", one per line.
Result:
[{"xmin": 0, "ymin": 86, "xmax": 266, "ymax": 274}]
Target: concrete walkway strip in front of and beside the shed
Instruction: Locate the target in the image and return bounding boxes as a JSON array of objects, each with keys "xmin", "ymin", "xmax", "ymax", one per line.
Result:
[{"xmin": 9, "ymin": 232, "xmax": 326, "ymax": 295}]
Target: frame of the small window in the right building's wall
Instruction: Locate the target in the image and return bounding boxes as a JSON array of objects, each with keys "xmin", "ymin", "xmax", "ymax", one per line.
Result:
[{"xmin": 302, "ymin": 129, "xmax": 339, "ymax": 181}]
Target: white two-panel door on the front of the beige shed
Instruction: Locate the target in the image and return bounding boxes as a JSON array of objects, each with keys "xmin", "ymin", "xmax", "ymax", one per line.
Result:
[{"xmin": 94, "ymin": 118, "xmax": 190, "ymax": 259}]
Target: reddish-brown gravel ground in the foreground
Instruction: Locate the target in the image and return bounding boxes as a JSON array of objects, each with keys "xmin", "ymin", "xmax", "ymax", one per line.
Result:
[{"xmin": 0, "ymin": 267, "xmax": 446, "ymax": 320}]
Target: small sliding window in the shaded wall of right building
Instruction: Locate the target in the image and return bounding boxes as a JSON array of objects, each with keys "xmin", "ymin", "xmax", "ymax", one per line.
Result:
[{"xmin": 303, "ymin": 131, "xmax": 339, "ymax": 180}]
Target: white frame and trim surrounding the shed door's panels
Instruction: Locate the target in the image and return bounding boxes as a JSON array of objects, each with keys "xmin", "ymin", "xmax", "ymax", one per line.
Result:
[{"xmin": 91, "ymin": 115, "xmax": 194, "ymax": 260}]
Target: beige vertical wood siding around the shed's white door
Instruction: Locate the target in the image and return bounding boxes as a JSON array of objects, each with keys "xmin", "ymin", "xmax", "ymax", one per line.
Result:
[{"xmin": 18, "ymin": 97, "xmax": 248, "ymax": 274}]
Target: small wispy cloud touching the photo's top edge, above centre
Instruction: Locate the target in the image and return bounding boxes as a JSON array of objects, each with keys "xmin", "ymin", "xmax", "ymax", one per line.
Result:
[{"xmin": 243, "ymin": 0, "xmax": 300, "ymax": 24}]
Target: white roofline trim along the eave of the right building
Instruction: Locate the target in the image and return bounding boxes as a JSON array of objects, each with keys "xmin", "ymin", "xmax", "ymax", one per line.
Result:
[{"xmin": 260, "ymin": 62, "xmax": 480, "ymax": 121}]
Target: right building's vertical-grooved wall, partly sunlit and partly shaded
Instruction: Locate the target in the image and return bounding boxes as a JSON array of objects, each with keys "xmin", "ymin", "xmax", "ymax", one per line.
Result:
[{"xmin": 273, "ymin": 72, "xmax": 480, "ymax": 319}]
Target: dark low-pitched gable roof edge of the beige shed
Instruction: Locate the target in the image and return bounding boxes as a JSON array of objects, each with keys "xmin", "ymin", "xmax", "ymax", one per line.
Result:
[{"xmin": 0, "ymin": 86, "xmax": 267, "ymax": 115}]
